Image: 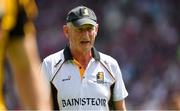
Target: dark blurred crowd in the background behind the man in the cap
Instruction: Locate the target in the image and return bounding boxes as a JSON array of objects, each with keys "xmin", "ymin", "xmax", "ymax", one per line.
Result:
[{"xmin": 5, "ymin": 0, "xmax": 180, "ymax": 110}]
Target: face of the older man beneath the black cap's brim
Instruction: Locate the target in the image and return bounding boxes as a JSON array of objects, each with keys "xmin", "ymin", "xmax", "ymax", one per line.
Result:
[{"xmin": 68, "ymin": 24, "xmax": 98, "ymax": 53}]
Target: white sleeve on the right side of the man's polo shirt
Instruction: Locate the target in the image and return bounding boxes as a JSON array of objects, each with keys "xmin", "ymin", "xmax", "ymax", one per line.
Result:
[{"xmin": 113, "ymin": 62, "xmax": 128, "ymax": 101}]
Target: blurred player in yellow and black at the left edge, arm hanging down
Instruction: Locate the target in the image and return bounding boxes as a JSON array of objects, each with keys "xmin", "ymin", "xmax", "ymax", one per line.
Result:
[{"xmin": 0, "ymin": 0, "xmax": 51, "ymax": 110}]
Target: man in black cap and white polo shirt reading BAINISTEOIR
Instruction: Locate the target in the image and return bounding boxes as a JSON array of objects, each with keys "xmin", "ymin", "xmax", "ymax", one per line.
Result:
[{"xmin": 42, "ymin": 6, "xmax": 128, "ymax": 110}]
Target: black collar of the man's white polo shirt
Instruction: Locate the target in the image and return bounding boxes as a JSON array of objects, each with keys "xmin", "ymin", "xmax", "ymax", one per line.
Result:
[{"xmin": 63, "ymin": 45, "xmax": 100, "ymax": 61}]
